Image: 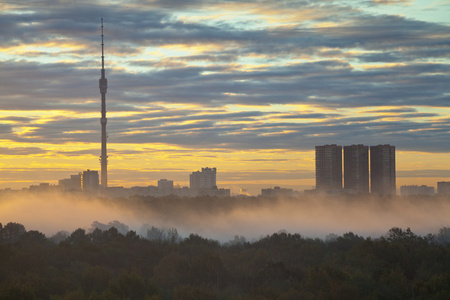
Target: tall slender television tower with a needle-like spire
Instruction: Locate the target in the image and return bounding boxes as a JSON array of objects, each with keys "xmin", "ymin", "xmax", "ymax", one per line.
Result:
[{"xmin": 98, "ymin": 18, "xmax": 108, "ymax": 188}]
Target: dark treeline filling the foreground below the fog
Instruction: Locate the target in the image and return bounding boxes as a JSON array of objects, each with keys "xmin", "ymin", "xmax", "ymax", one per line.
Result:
[{"xmin": 0, "ymin": 223, "xmax": 450, "ymax": 300}]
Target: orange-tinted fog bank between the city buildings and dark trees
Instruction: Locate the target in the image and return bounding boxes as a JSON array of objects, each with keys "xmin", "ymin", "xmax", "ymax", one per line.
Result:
[{"xmin": 0, "ymin": 192, "xmax": 450, "ymax": 241}]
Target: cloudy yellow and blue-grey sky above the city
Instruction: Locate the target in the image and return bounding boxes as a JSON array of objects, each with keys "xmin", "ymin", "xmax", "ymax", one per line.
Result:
[{"xmin": 0, "ymin": 0, "xmax": 450, "ymax": 194}]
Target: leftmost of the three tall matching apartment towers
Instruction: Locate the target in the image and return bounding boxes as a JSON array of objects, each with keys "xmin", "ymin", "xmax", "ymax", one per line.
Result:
[{"xmin": 316, "ymin": 144, "xmax": 342, "ymax": 190}]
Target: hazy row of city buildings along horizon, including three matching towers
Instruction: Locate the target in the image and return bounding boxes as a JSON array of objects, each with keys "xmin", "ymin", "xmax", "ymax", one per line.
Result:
[{"xmin": 7, "ymin": 157, "xmax": 450, "ymax": 198}]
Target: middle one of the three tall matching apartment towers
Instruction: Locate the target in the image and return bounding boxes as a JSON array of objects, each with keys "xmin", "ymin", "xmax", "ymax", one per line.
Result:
[{"xmin": 344, "ymin": 145, "xmax": 369, "ymax": 193}]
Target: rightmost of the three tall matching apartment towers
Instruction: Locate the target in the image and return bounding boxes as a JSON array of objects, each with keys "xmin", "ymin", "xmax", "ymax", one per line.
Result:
[{"xmin": 370, "ymin": 145, "xmax": 396, "ymax": 195}]
